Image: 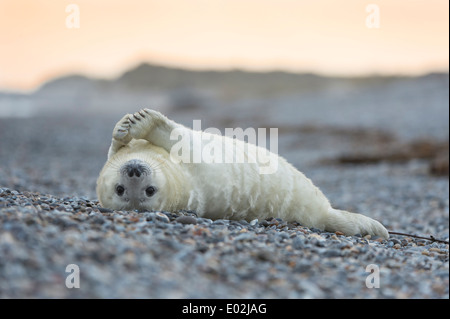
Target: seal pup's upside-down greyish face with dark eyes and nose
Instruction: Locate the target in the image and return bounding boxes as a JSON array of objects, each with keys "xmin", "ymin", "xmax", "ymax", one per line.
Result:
[{"xmin": 97, "ymin": 159, "xmax": 161, "ymax": 210}]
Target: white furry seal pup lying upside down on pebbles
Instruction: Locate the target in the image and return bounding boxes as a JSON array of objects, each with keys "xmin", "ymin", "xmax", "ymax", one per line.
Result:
[{"xmin": 97, "ymin": 109, "xmax": 389, "ymax": 238}]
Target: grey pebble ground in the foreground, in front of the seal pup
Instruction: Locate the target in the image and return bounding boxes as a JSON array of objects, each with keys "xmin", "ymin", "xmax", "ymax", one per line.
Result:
[{"xmin": 0, "ymin": 188, "xmax": 449, "ymax": 298}]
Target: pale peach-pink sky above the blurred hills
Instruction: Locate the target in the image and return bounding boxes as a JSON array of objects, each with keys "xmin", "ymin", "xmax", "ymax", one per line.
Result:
[{"xmin": 0, "ymin": 0, "xmax": 449, "ymax": 90}]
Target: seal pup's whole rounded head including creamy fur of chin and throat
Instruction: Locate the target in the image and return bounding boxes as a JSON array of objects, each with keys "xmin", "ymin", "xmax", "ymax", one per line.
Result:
[{"xmin": 97, "ymin": 140, "xmax": 191, "ymax": 211}]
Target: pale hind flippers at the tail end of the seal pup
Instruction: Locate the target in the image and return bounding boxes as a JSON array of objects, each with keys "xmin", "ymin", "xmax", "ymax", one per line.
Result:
[{"xmin": 325, "ymin": 208, "xmax": 389, "ymax": 239}]
